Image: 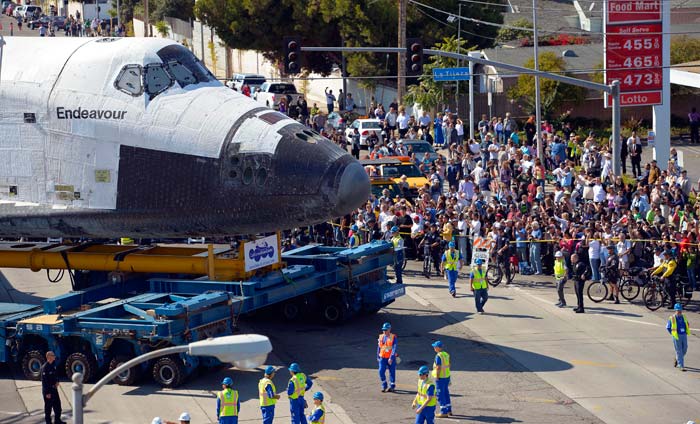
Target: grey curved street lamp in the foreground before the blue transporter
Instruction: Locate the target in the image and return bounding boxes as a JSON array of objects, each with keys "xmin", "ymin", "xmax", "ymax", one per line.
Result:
[{"xmin": 71, "ymin": 334, "xmax": 272, "ymax": 424}]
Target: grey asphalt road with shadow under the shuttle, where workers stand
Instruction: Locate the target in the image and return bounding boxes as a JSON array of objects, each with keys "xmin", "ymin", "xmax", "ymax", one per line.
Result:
[{"xmin": 0, "ymin": 262, "xmax": 700, "ymax": 424}]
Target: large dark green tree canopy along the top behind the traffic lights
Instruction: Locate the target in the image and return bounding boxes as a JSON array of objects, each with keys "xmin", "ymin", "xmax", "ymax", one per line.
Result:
[{"xmin": 194, "ymin": 0, "xmax": 503, "ymax": 76}]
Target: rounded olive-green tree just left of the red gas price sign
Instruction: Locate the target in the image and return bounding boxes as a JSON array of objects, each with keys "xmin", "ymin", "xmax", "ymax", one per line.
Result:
[{"xmin": 508, "ymin": 52, "xmax": 586, "ymax": 116}]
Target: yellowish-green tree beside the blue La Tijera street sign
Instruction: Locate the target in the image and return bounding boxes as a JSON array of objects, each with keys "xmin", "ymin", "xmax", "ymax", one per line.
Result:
[{"xmin": 404, "ymin": 36, "xmax": 473, "ymax": 110}]
